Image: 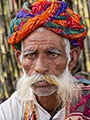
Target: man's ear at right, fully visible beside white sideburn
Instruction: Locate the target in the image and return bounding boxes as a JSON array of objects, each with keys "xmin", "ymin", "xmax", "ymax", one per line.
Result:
[{"xmin": 68, "ymin": 48, "xmax": 80, "ymax": 71}]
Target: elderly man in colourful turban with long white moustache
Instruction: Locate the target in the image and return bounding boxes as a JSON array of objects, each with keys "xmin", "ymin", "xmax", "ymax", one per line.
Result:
[{"xmin": 0, "ymin": 0, "xmax": 90, "ymax": 120}]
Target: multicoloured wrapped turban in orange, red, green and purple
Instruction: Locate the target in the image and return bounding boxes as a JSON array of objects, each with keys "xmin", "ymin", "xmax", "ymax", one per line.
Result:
[{"xmin": 8, "ymin": 0, "xmax": 87, "ymax": 50}]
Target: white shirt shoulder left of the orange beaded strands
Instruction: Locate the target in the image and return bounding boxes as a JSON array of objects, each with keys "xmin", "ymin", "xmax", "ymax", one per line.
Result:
[{"xmin": 0, "ymin": 91, "xmax": 24, "ymax": 120}]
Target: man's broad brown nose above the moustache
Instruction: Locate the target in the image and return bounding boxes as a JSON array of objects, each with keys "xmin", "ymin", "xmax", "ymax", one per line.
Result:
[{"xmin": 35, "ymin": 57, "xmax": 49, "ymax": 74}]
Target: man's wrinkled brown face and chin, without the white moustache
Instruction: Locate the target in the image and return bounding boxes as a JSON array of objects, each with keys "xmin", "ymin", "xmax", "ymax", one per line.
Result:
[{"xmin": 21, "ymin": 30, "xmax": 68, "ymax": 95}]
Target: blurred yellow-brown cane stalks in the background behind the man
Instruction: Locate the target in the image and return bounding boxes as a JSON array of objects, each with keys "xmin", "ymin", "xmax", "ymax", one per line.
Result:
[{"xmin": 0, "ymin": 0, "xmax": 90, "ymax": 103}]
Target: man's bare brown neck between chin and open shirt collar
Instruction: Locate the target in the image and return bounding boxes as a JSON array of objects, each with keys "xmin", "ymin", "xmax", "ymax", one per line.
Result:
[{"xmin": 36, "ymin": 93, "xmax": 61, "ymax": 115}]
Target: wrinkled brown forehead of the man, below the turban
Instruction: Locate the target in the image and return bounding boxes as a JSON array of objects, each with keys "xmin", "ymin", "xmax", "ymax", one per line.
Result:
[{"xmin": 23, "ymin": 28, "xmax": 65, "ymax": 49}]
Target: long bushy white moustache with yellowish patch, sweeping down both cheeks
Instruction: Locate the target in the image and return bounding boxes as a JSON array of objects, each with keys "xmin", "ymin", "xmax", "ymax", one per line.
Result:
[{"xmin": 17, "ymin": 66, "xmax": 78, "ymax": 104}]
